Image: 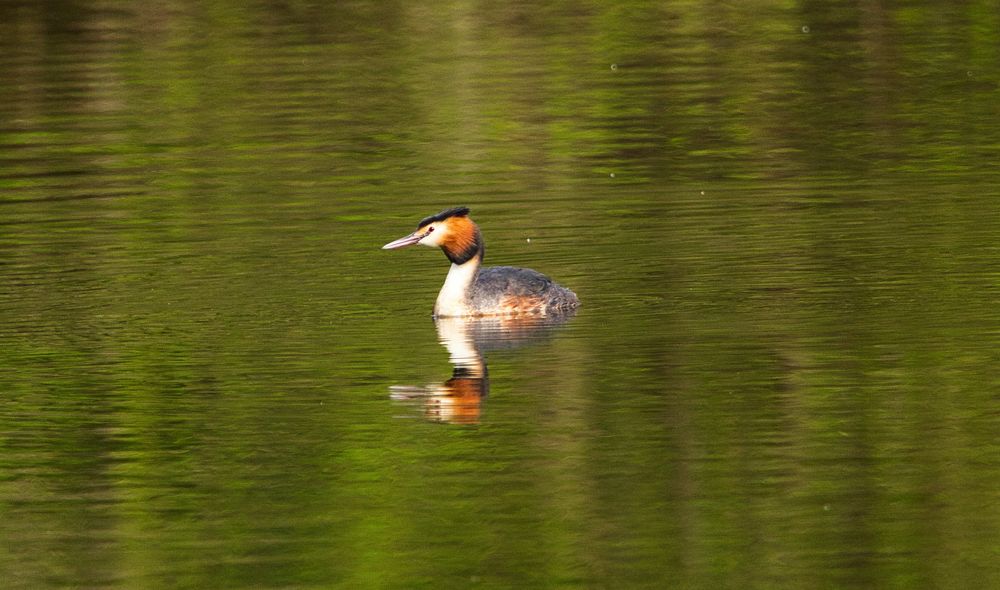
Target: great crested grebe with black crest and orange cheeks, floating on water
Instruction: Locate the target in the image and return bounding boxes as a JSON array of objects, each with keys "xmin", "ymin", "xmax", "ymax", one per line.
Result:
[{"xmin": 382, "ymin": 207, "xmax": 580, "ymax": 317}]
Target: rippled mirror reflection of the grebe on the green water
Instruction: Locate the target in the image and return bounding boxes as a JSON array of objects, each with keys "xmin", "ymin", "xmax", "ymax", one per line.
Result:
[{"xmin": 389, "ymin": 313, "xmax": 573, "ymax": 424}]
